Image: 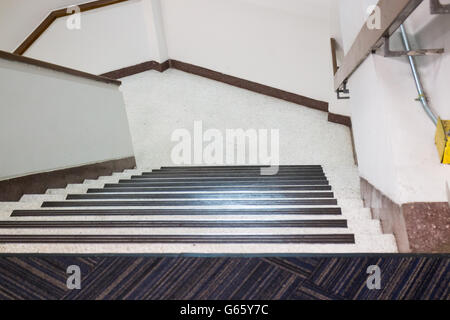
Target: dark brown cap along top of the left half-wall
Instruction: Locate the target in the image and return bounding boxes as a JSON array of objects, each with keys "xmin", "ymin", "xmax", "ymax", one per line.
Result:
[{"xmin": 0, "ymin": 50, "xmax": 122, "ymax": 86}]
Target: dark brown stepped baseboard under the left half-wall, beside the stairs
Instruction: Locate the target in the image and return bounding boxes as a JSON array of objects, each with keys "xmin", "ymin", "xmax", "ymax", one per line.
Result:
[{"xmin": 0, "ymin": 157, "xmax": 136, "ymax": 201}]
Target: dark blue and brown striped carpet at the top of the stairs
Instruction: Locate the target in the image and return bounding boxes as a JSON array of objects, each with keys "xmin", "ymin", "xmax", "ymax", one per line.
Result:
[{"xmin": 0, "ymin": 255, "xmax": 450, "ymax": 300}]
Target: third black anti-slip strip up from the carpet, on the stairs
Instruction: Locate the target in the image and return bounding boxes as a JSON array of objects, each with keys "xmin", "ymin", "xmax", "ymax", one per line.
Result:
[{"xmin": 11, "ymin": 207, "xmax": 342, "ymax": 217}]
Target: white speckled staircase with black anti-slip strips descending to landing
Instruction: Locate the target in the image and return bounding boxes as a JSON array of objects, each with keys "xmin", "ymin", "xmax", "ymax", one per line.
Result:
[{"xmin": 0, "ymin": 165, "xmax": 397, "ymax": 254}]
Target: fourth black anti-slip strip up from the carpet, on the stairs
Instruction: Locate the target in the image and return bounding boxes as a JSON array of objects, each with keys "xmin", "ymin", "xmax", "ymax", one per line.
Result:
[{"xmin": 42, "ymin": 199, "xmax": 337, "ymax": 208}]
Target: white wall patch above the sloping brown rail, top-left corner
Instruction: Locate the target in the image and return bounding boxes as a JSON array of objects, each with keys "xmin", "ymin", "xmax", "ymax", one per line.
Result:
[{"xmin": 0, "ymin": 0, "xmax": 84, "ymax": 52}]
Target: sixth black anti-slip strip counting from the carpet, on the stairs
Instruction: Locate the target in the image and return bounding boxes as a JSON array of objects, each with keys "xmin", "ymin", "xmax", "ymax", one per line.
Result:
[{"xmin": 91, "ymin": 186, "xmax": 331, "ymax": 193}]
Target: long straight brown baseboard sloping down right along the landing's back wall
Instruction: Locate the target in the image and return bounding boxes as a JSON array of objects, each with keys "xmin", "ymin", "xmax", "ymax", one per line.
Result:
[{"xmin": 170, "ymin": 59, "xmax": 328, "ymax": 112}]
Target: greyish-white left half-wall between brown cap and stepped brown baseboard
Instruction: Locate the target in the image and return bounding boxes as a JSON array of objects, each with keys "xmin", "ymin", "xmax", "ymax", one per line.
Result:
[{"xmin": 0, "ymin": 55, "xmax": 133, "ymax": 180}]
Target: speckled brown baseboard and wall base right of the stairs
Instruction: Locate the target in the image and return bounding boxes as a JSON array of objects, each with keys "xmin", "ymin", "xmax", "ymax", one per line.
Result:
[{"xmin": 361, "ymin": 178, "xmax": 450, "ymax": 253}]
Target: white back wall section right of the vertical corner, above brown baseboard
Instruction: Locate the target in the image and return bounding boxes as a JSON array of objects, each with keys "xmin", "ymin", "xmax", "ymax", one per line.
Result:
[{"xmin": 162, "ymin": 0, "xmax": 332, "ymax": 101}]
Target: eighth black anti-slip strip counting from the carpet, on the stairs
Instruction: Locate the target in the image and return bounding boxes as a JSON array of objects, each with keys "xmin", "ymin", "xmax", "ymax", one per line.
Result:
[{"xmin": 126, "ymin": 176, "xmax": 327, "ymax": 182}]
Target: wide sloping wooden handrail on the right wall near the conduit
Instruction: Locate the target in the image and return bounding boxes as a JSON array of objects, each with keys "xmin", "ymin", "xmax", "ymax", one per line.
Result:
[{"xmin": 334, "ymin": 0, "xmax": 423, "ymax": 90}]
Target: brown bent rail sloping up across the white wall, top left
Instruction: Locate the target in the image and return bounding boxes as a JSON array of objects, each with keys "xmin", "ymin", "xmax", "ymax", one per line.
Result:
[{"xmin": 14, "ymin": 0, "xmax": 129, "ymax": 55}]
